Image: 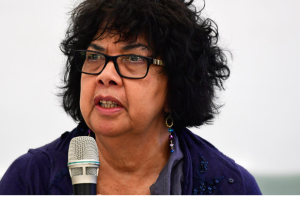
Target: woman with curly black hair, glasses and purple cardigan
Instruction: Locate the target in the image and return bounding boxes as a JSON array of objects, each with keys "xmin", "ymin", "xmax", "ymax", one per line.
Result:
[{"xmin": 0, "ymin": 0, "xmax": 261, "ymax": 196}]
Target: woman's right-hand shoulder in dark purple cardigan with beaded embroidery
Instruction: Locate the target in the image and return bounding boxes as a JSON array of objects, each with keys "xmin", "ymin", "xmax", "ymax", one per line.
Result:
[{"xmin": 179, "ymin": 129, "xmax": 261, "ymax": 196}]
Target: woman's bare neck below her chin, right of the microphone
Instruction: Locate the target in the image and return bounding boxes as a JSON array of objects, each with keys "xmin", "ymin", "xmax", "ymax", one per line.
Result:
[{"xmin": 96, "ymin": 121, "xmax": 170, "ymax": 176}]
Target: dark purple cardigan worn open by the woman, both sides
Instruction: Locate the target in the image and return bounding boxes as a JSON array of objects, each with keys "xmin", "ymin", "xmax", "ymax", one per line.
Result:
[{"xmin": 0, "ymin": 124, "xmax": 262, "ymax": 196}]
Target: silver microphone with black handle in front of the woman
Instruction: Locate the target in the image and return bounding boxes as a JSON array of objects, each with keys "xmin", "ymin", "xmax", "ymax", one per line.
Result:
[{"xmin": 68, "ymin": 136, "xmax": 100, "ymax": 196}]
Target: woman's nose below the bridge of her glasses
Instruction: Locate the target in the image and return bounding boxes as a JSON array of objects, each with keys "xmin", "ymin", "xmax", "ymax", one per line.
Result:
[{"xmin": 96, "ymin": 60, "xmax": 123, "ymax": 86}]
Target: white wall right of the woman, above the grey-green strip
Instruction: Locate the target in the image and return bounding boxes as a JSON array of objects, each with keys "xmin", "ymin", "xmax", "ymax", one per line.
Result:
[{"xmin": 193, "ymin": 0, "xmax": 300, "ymax": 174}]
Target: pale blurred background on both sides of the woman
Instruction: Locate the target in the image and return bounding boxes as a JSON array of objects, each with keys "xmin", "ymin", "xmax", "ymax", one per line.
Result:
[{"xmin": 0, "ymin": 0, "xmax": 300, "ymax": 195}]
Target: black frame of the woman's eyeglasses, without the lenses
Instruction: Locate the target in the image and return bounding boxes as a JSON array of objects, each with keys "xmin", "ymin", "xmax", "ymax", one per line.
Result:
[{"xmin": 74, "ymin": 50, "xmax": 165, "ymax": 79}]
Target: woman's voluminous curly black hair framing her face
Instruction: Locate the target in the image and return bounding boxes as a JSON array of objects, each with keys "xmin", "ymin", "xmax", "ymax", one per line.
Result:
[{"xmin": 60, "ymin": 0, "xmax": 230, "ymax": 129}]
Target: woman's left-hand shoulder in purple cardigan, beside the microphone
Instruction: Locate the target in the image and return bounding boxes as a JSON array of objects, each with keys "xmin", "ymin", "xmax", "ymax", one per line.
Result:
[{"xmin": 0, "ymin": 122, "xmax": 84, "ymax": 196}]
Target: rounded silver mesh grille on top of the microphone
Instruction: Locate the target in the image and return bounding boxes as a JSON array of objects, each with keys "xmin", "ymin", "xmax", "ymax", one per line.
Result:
[{"xmin": 68, "ymin": 136, "xmax": 99, "ymax": 161}]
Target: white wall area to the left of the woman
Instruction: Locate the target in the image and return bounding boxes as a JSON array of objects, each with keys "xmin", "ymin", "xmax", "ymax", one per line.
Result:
[{"xmin": 0, "ymin": 0, "xmax": 75, "ymax": 176}]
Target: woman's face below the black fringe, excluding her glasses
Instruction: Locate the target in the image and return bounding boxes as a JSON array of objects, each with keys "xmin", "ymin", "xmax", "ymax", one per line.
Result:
[{"xmin": 80, "ymin": 35, "xmax": 167, "ymax": 137}]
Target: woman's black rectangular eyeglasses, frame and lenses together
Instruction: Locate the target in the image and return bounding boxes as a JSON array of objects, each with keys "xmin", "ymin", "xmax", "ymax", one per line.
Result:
[{"xmin": 75, "ymin": 50, "xmax": 165, "ymax": 79}]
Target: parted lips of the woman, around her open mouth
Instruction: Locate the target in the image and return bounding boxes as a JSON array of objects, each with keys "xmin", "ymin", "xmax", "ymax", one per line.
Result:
[{"xmin": 94, "ymin": 95, "xmax": 123, "ymax": 115}]
